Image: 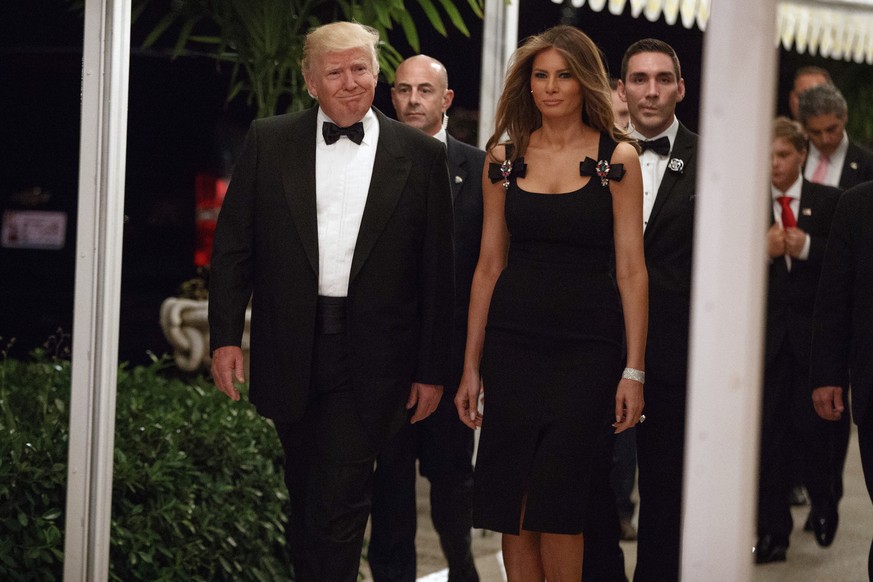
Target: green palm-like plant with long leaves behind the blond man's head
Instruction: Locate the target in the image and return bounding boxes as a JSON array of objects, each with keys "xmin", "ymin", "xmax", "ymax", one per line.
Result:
[{"xmin": 70, "ymin": 0, "xmax": 483, "ymax": 117}]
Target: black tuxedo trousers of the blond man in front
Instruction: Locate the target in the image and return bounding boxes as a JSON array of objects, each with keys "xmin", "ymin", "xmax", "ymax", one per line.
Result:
[{"xmin": 274, "ymin": 333, "xmax": 376, "ymax": 582}]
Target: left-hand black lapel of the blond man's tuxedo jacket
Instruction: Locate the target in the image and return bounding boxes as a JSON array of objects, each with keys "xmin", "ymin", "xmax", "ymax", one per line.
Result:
[{"xmin": 278, "ymin": 107, "xmax": 318, "ymax": 273}]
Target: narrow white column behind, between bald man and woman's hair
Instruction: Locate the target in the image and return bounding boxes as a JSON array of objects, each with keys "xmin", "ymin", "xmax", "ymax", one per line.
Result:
[{"xmin": 478, "ymin": 0, "xmax": 521, "ymax": 148}]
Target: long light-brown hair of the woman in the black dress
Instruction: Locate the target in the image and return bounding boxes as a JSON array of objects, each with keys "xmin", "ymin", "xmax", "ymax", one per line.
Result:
[{"xmin": 485, "ymin": 25, "xmax": 633, "ymax": 159}]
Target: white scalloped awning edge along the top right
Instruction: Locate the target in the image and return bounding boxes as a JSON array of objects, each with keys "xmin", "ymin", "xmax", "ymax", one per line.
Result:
[{"xmin": 552, "ymin": 0, "xmax": 873, "ymax": 64}]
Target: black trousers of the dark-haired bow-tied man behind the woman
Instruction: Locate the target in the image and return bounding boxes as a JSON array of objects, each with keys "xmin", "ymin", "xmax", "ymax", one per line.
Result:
[{"xmin": 634, "ymin": 373, "xmax": 687, "ymax": 582}]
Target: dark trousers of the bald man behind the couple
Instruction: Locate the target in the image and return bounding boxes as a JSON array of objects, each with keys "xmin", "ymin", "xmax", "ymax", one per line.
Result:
[{"xmin": 367, "ymin": 394, "xmax": 479, "ymax": 582}]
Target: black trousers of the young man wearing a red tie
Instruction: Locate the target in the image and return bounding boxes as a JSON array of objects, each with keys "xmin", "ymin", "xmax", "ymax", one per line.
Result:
[{"xmin": 757, "ymin": 340, "xmax": 842, "ymax": 545}]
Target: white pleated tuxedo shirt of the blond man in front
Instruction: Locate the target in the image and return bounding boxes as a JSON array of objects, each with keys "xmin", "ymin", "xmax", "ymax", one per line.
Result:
[{"xmin": 315, "ymin": 109, "xmax": 379, "ymax": 297}]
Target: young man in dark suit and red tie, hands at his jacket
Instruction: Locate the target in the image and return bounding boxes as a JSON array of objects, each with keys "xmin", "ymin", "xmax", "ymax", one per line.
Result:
[{"xmin": 753, "ymin": 117, "xmax": 840, "ymax": 564}]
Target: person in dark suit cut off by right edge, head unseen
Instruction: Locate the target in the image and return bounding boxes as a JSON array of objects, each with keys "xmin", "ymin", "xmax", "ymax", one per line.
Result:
[{"xmin": 810, "ymin": 182, "xmax": 873, "ymax": 580}]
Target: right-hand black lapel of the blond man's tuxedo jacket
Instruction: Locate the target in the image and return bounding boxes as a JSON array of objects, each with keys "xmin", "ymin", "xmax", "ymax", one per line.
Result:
[{"xmin": 349, "ymin": 108, "xmax": 412, "ymax": 281}]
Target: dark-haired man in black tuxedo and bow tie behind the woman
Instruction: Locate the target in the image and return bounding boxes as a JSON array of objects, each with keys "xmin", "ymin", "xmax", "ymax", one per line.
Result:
[{"xmin": 619, "ymin": 39, "xmax": 697, "ymax": 582}]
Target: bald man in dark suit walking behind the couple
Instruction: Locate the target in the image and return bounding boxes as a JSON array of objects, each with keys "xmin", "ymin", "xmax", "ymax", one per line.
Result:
[{"xmin": 368, "ymin": 55, "xmax": 485, "ymax": 582}]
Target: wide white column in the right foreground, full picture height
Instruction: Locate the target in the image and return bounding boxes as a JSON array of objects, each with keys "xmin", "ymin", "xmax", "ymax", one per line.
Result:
[{"xmin": 682, "ymin": 0, "xmax": 777, "ymax": 582}]
